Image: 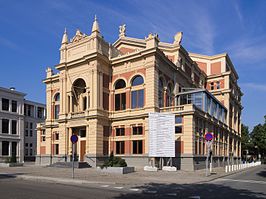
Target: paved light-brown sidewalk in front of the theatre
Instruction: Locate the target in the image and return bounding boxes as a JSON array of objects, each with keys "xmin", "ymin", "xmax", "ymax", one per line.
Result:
[{"xmin": 0, "ymin": 164, "xmax": 258, "ymax": 187}]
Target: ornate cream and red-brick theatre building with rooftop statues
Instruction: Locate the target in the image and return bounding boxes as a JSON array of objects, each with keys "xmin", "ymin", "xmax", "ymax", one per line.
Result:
[{"xmin": 36, "ymin": 19, "xmax": 242, "ymax": 170}]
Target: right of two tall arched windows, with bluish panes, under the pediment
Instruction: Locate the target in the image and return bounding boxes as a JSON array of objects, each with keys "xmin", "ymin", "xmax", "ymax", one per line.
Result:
[{"xmin": 131, "ymin": 75, "xmax": 144, "ymax": 109}]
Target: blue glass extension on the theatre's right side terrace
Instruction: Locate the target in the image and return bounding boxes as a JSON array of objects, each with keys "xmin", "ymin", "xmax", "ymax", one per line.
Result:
[{"xmin": 176, "ymin": 89, "xmax": 227, "ymax": 123}]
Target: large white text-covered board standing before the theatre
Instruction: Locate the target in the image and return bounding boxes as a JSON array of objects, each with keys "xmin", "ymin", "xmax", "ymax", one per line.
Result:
[{"xmin": 149, "ymin": 113, "xmax": 175, "ymax": 157}]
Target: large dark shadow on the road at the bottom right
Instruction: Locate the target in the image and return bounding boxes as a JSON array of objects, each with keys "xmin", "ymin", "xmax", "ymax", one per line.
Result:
[{"xmin": 115, "ymin": 183, "xmax": 266, "ymax": 199}]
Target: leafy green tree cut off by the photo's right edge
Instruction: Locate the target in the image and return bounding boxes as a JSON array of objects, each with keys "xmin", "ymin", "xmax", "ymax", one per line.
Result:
[{"xmin": 251, "ymin": 116, "xmax": 266, "ymax": 158}]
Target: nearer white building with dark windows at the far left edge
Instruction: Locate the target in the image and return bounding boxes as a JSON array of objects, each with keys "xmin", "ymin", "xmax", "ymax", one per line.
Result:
[{"xmin": 0, "ymin": 87, "xmax": 26, "ymax": 162}]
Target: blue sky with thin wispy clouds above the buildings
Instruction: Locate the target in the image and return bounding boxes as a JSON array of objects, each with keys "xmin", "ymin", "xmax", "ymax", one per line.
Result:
[{"xmin": 0, "ymin": 0, "xmax": 266, "ymax": 129}]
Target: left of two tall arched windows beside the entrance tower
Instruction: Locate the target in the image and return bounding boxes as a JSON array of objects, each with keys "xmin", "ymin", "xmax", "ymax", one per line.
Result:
[{"xmin": 114, "ymin": 79, "xmax": 126, "ymax": 111}]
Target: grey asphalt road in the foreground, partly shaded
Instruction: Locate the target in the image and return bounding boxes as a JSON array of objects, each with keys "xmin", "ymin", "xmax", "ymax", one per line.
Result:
[{"xmin": 0, "ymin": 165, "xmax": 266, "ymax": 199}]
